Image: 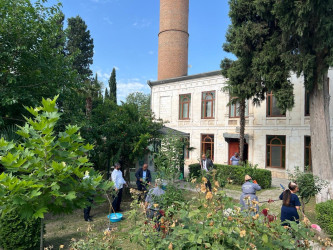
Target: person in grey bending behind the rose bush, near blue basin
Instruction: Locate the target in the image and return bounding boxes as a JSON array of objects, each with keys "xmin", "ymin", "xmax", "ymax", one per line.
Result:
[{"xmin": 145, "ymin": 179, "xmax": 165, "ymax": 220}]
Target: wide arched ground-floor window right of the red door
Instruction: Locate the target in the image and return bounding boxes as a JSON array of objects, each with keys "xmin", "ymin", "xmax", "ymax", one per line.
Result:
[{"xmin": 266, "ymin": 135, "xmax": 286, "ymax": 168}]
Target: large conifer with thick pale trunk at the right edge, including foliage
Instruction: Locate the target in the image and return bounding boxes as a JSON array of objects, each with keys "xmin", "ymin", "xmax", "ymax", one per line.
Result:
[{"xmin": 249, "ymin": 0, "xmax": 333, "ymax": 202}]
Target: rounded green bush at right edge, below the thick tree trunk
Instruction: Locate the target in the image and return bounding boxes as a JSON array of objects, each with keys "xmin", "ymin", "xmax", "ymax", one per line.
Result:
[{"xmin": 316, "ymin": 200, "xmax": 333, "ymax": 238}]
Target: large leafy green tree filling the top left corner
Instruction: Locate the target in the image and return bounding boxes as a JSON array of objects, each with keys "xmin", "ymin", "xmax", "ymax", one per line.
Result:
[{"xmin": 0, "ymin": 0, "xmax": 77, "ymax": 128}]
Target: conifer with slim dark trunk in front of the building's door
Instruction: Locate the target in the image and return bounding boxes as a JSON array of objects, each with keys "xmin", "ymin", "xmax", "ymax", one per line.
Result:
[{"xmin": 221, "ymin": 0, "xmax": 294, "ymax": 160}]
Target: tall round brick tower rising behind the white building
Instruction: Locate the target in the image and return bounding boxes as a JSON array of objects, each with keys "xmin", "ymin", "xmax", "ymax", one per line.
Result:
[{"xmin": 157, "ymin": 0, "xmax": 189, "ymax": 80}]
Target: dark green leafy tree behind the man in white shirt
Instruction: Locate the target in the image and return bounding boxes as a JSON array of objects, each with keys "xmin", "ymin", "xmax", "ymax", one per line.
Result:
[{"xmin": 87, "ymin": 99, "xmax": 162, "ymax": 178}]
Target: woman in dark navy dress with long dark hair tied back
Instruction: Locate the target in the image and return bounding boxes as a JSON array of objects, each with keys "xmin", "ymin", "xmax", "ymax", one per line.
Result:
[{"xmin": 279, "ymin": 182, "xmax": 301, "ymax": 226}]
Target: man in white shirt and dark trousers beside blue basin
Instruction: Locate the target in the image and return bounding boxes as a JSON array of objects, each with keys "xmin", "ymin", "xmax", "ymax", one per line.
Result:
[{"xmin": 111, "ymin": 163, "xmax": 128, "ymax": 212}]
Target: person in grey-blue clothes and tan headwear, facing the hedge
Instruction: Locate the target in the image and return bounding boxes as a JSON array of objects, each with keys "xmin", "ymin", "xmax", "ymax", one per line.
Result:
[{"xmin": 239, "ymin": 175, "xmax": 261, "ymax": 213}]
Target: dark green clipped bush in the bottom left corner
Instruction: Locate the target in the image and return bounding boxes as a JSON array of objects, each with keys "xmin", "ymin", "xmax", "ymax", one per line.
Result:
[{"xmin": 0, "ymin": 211, "xmax": 41, "ymax": 250}]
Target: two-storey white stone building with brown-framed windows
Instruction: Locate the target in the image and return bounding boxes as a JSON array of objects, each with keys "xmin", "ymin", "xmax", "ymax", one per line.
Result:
[{"xmin": 148, "ymin": 70, "xmax": 333, "ymax": 177}]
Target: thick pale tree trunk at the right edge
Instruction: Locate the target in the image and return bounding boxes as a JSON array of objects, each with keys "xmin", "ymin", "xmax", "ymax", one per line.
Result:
[{"xmin": 310, "ymin": 75, "xmax": 333, "ymax": 203}]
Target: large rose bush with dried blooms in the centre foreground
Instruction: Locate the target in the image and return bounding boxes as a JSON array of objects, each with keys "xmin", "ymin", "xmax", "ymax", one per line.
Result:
[{"xmin": 131, "ymin": 179, "xmax": 313, "ymax": 250}]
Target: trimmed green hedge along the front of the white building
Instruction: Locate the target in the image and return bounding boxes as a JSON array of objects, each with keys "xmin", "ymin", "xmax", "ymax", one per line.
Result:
[{"xmin": 189, "ymin": 163, "xmax": 272, "ymax": 188}]
